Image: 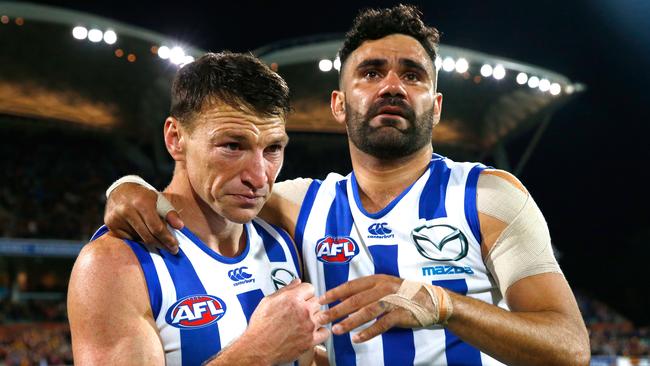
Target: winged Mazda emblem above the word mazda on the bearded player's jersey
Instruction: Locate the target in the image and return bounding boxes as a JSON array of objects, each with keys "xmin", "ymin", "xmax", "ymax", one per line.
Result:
[{"xmin": 411, "ymin": 222, "xmax": 468, "ymax": 261}]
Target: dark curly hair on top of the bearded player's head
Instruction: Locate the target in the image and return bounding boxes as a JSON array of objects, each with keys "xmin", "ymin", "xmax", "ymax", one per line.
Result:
[{"xmin": 339, "ymin": 4, "xmax": 440, "ymax": 69}]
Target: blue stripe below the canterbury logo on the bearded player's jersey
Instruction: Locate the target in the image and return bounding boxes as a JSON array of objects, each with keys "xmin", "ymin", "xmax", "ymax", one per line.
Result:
[{"xmin": 368, "ymin": 244, "xmax": 415, "ymax": 366}]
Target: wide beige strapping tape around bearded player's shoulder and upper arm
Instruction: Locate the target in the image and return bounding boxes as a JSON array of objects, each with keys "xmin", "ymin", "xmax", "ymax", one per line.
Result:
[{"xmin": 477, "ymin": 174, "xmax": 562, "ymax": 297}]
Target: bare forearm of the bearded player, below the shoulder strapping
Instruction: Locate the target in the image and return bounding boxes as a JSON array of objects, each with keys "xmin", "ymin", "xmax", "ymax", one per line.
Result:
[{"xmin": 447, "ymin": 292, "xmax": 589, "ymax": 365}]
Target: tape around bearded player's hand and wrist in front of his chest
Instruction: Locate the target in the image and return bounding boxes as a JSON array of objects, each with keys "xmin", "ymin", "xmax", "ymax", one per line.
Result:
[{"xmin": 381, "ymin": 280, "xmax": 454, "ymax": 327}]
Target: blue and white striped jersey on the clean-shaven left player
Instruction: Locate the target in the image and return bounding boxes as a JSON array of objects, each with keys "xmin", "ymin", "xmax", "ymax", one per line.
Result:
[{"xmin": 93, "ymin": 219, "xmax": 301, "ymax": 366}]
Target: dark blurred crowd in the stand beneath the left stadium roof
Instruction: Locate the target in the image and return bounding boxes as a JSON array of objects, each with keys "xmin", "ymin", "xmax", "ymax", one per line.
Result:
[{"xmin": 0, "ymin": 131, "xmax": 160, "ymax": 240}]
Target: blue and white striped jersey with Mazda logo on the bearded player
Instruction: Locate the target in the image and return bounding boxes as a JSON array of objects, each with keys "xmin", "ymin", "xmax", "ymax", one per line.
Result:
[{"xmin": 295, "ymin": 154, "xmax": 505, "ymax": 366}]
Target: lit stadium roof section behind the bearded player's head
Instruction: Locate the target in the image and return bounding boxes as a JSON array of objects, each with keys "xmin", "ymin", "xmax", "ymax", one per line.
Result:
[{"xmin": 256, "ymin": 36, "xmax": 584, "ymax": 162}]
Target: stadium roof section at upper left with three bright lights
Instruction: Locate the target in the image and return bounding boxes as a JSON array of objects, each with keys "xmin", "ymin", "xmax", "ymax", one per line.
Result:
[{"xmin": 0, "ymin": 2, "xmax": 203, "ymax": 134}]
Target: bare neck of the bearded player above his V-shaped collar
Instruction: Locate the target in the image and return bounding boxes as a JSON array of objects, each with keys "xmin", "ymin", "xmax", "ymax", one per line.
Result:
[{"xmin": 350, "ymin": 144, "xmax": 433, "ymax": 213}]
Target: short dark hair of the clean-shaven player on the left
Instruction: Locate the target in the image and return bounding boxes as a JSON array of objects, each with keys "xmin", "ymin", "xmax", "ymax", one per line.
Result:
[{"xmin": 169, "ymin": 51, "xmax": 291, "ymax": 127}]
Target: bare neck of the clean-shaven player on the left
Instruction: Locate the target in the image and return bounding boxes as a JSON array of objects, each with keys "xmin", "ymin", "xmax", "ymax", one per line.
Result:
[{"xmin": 164, "ymin": 172, "xmax": 246, "ymax": 257}]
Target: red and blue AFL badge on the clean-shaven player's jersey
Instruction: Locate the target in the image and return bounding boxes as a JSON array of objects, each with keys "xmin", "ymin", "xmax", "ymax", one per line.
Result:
[{"xmin": 165, "ymin": 295, "xmax": 226, "ymax": 329}]
